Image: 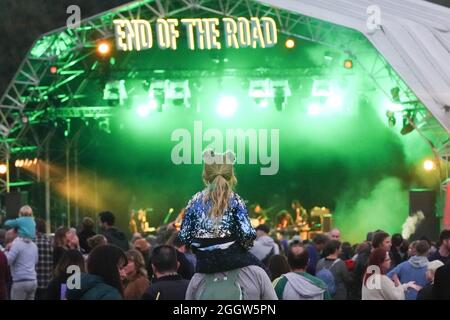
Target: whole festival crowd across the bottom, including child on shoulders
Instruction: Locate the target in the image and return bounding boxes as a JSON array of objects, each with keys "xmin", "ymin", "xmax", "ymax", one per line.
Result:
[{"xmin": 0, "ymin": 151, "xmax": 450, "ymax": 300}]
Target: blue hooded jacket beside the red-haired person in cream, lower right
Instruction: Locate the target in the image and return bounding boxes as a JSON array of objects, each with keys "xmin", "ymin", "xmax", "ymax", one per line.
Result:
[{"xmin": 387, "ymin": 256, "xmax": 428, "ymax": 300}]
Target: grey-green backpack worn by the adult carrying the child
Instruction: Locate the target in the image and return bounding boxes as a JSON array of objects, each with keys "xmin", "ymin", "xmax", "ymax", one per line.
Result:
[{"xmin": 199, "ymin": 269, "xmax": 244, "ymax": 300}]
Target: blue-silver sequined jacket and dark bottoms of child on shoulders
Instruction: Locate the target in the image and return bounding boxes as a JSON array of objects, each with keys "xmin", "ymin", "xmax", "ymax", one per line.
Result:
[{"xmin": 179, "ymin": 190, "xmax": 259, "ymax": 273}]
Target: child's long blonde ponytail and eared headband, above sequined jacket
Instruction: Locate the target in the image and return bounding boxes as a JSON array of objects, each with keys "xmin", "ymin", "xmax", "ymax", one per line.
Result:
[{"xmin": 202, "ymin": 150, "xmax": 237, "ymax": 219}]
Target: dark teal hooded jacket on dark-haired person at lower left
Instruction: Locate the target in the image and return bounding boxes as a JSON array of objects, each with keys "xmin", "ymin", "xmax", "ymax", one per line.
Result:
[{"xmin": 67, "ymin": 273, "xmax": 122, "ymax": 300}]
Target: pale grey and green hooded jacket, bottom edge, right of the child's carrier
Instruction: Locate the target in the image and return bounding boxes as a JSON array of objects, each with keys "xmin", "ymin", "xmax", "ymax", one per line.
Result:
[{"xmin": 274, "ymin": 272, "xmax": 330, "ymax": 300}]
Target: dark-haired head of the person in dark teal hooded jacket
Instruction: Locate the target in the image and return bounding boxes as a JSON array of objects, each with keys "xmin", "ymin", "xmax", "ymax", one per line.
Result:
[{"xmin": 87, "ymin": 244, "xmax": 127, "ymax": 294}]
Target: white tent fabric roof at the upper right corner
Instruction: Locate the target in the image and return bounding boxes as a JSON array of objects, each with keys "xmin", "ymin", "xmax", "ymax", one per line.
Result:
[{"xmin": 258, "ymin": 0, "xmax": 450, "ymax": 132}]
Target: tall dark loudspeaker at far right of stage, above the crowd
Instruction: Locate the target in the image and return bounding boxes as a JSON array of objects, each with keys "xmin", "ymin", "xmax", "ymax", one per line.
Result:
[{"xmin": 409, "ymin": 189, "xmax": 439, "ymax": 240}]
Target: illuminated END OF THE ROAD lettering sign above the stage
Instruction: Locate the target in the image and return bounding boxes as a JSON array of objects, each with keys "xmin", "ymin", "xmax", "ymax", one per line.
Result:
[{"xmin": 113, "ymin": 17, "xmax": 278, "ymax": 51}]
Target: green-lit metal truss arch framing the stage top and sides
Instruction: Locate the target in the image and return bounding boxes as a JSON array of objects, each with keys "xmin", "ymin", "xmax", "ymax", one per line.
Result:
[{"xmin": 0, "ymin": 0, "xmax": 450, "ymax": 190}]
